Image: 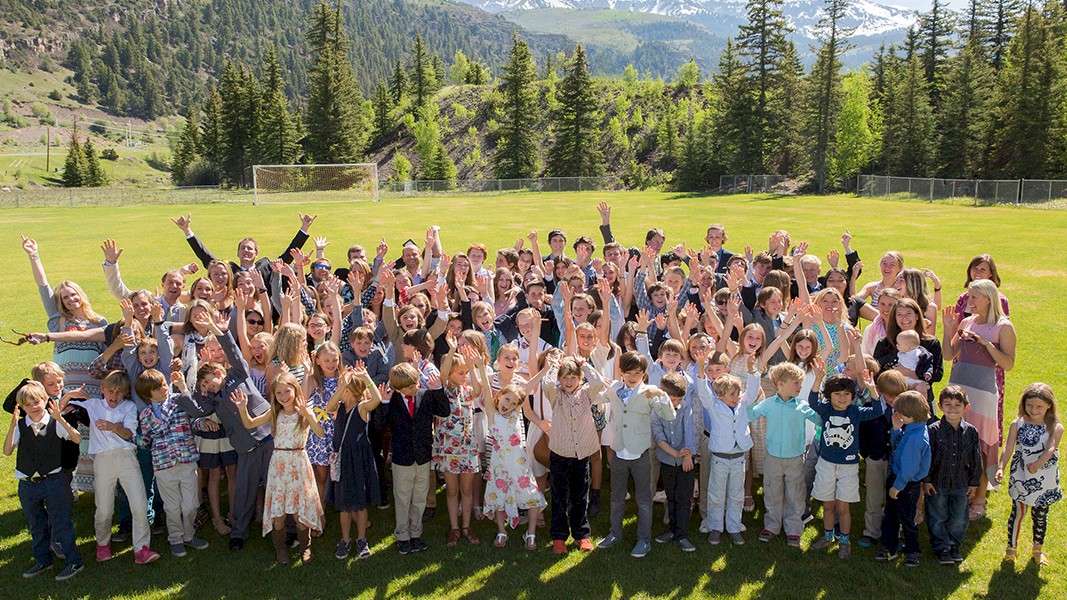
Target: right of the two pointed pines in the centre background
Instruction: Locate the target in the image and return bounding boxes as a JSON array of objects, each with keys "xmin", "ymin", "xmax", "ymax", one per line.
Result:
[{"xmin": 548, "ymin": 44, "xmax": 603, "ymax": 177}]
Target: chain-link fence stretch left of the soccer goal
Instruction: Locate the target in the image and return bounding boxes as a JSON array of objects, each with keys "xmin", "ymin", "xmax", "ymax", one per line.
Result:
[{"xmin": 0, "ymin": 186, "xmax": 234, "ymax": 208}]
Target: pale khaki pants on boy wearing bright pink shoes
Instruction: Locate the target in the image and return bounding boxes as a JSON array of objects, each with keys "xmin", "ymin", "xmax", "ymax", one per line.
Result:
[{"xmin": 93, "ymin": 448, "xmax": 152, "ymax": 551}]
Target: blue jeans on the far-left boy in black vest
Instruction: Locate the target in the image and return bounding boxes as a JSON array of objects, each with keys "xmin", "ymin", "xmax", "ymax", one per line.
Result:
[{"xmin": 18, "ymin": 475, "xmax": 81, "ymax": 566}]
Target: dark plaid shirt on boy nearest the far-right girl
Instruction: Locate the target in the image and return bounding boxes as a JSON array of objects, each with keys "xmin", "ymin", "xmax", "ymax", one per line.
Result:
[{"xmin": 923, "ymin": 417, "xmax": 982, "ymax": 490}]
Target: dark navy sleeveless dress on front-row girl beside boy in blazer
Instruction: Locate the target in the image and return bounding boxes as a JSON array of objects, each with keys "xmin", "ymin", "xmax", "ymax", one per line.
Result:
[{"xmin": 327, "ymin": 402, "xmax": 382, "ymax": 512}]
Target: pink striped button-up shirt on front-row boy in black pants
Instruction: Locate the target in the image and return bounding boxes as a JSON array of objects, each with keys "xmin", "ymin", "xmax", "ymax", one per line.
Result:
[{"xmin": 541, "ymin": 363, "xmax": 607, "ymax": 458}]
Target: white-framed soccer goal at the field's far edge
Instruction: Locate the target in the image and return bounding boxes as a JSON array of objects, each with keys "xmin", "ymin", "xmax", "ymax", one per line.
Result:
[{"xmin": 252, "ymin": 162, "xmax": 378, "ymax": 204}]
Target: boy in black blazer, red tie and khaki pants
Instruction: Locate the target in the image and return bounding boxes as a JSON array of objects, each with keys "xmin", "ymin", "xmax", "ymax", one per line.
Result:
[{"xmin": 383, "ymin": 363, "xmax": 450, "ymax": 554}]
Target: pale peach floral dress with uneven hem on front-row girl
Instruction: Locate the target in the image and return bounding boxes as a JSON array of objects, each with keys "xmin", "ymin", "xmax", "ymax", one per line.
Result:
[{"xmin": 264, "ymin": 413, "xmax": 323, "ymax": 536}]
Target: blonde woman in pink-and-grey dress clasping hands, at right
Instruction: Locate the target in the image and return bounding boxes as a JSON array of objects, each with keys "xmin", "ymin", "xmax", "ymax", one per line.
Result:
[{"xmin": 941, "ymin": 280, "xmax": 1017, "ymax": 520}]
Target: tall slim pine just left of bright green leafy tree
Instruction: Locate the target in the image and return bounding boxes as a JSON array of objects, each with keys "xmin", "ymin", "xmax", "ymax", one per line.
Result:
[{"xmin": 808, "ymin": 0, "xmax": 851, "ymax": 193}]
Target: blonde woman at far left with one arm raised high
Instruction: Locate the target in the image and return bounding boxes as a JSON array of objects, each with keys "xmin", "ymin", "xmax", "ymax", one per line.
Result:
[{"xmin": 22, "ymin": 236, "xmax": 108, "ymax": 492}]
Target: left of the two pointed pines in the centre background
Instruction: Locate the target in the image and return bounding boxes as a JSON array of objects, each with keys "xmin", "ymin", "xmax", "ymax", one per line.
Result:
[{"xmin": 493, "ymin": 32, "xmax": 540, "ymax": 179}]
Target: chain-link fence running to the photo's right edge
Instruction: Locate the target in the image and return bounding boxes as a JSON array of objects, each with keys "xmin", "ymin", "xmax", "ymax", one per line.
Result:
[{"xmin": 857, "ymin": 175, "xmax": 1067, "ymax": 208}]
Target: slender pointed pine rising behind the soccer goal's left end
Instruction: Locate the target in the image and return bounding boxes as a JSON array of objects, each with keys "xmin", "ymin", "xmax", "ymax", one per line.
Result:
[{"xmin": 256, "ymin": 48, "xmax": 302, "ymax": 164}]
